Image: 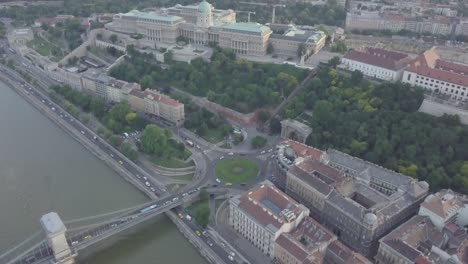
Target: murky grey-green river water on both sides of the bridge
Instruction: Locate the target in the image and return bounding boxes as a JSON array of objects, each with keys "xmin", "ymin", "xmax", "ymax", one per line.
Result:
[{"xmin": 0, "ymin": 83, "xmax": 206, "ymax": 264}]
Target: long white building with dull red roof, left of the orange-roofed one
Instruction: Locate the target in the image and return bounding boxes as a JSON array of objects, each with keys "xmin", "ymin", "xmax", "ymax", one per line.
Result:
[{"xmin": 340, "ymin": 47, "xmax": 411, "ymax": 81}]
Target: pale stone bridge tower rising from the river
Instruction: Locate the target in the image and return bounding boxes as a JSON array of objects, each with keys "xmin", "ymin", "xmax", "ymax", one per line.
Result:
[{"xmin": 41, "ymin": 212, "xmax": 76, "ymax": 264}]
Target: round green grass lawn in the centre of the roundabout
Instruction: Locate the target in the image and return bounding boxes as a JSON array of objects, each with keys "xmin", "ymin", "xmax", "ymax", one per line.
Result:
[{"xmin": 215, "ymin": 158, "xmax": 258, "ymax": 183}]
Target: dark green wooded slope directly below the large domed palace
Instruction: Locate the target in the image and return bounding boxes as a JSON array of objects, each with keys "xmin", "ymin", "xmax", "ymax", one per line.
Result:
[{"xmin": 110, "ymin": 47, "xmax": 307, "ymax": 113}]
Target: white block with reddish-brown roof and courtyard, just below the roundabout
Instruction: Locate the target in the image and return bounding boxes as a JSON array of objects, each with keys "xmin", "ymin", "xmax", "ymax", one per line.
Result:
[{"xmin": 229, "ymin": 181, "xmax": 309, "ymax": 259}]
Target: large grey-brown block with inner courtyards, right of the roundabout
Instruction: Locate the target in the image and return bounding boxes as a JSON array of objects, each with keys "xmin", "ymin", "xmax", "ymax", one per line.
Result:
[{"xmin": 286, "ymin": 141, "xmax": 429, "ymax": 256}]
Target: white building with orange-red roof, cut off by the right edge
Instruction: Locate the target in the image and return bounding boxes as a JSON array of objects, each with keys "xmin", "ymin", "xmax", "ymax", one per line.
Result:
[{"xmin": 402, "ymin": 48, "xmax": 468, "ymax": 102}]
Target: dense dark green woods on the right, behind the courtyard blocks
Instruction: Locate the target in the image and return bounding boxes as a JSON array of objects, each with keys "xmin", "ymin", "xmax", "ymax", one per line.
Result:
[{"xmin": 283, "ymin": 64, "xmax": 468, "ymax": 192}]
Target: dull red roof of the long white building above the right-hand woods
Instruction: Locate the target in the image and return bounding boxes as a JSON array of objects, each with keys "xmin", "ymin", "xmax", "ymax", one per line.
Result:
[{"xmin": 344, "ymin": 47, "xmax": 409, "ymax": 71}]
